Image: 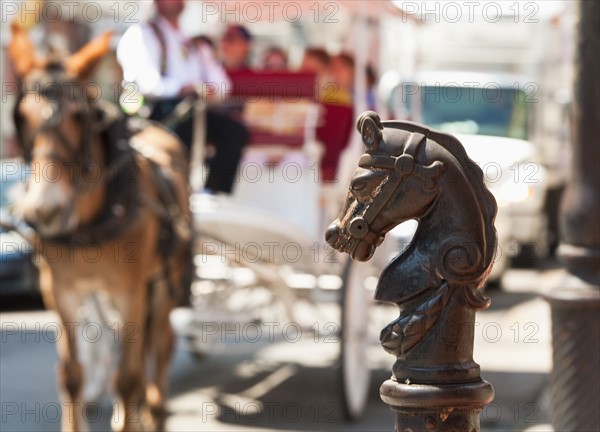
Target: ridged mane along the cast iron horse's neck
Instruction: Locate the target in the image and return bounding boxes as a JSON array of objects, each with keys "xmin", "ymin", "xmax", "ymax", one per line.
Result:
[{"xmin": 382, "ymin": 121, "xmax": 497, "ymax": 280}]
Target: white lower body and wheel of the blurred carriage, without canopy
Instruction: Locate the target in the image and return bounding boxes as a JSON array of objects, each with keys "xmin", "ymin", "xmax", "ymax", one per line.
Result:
[{"xmin": 183, "ymin": 73, "xmax": 394, "ymax": 419}]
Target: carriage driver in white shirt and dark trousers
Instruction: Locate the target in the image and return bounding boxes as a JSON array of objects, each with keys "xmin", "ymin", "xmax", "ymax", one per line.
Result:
[{"xmin": 117, "ymin": 0, "xmax": 248, "ymax": 193}]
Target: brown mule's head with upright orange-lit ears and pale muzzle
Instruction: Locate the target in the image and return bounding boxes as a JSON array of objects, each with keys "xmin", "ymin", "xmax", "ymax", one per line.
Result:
[{"xmin": 9, "ymin": 23, "xmax": 111, "ymax": 237}]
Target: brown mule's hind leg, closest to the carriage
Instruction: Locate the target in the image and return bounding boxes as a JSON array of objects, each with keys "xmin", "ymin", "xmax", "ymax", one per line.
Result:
[{"xmin": 146, "ymin": 278, "xmax": 174, "ymax": 430}]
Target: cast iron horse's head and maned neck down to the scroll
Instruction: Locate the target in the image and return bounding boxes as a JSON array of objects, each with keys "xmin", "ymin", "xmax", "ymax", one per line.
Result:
[{"xmin": 326, "ymin": 112, "xmax": 497, "ymax": 304}]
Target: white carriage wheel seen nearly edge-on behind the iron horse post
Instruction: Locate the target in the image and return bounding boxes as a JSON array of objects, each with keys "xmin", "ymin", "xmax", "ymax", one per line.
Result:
[{"xmin": 340, "ymin": 260, "xmax": 371, "ymax": 420}]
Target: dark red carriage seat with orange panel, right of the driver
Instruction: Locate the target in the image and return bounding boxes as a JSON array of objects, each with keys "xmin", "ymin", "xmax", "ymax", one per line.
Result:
[{"xmin": 230, "ymin": 71, "xmax": 354, "ymax": 182}]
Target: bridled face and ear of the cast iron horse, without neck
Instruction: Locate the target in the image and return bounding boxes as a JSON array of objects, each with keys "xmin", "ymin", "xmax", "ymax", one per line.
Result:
[{"xmin": 326, "ymin": 112, "xmax": 444, "ymax": 261}]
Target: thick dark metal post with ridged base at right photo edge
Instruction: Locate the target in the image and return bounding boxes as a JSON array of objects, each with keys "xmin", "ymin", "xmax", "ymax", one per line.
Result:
[{"xmin": 546, "ymin": 0, "xmax": 600, "ymax": 431}]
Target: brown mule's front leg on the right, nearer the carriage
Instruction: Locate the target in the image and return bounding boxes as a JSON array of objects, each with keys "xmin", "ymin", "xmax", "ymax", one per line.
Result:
[{"xmin": 113, "ymin": 284, "xmax": 149, "ymax": 432}]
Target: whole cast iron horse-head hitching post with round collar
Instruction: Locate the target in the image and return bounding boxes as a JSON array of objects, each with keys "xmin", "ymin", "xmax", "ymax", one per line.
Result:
[{"xmin": 327, "ymin": 112, "xmax": 496, "ymax": 432}]
